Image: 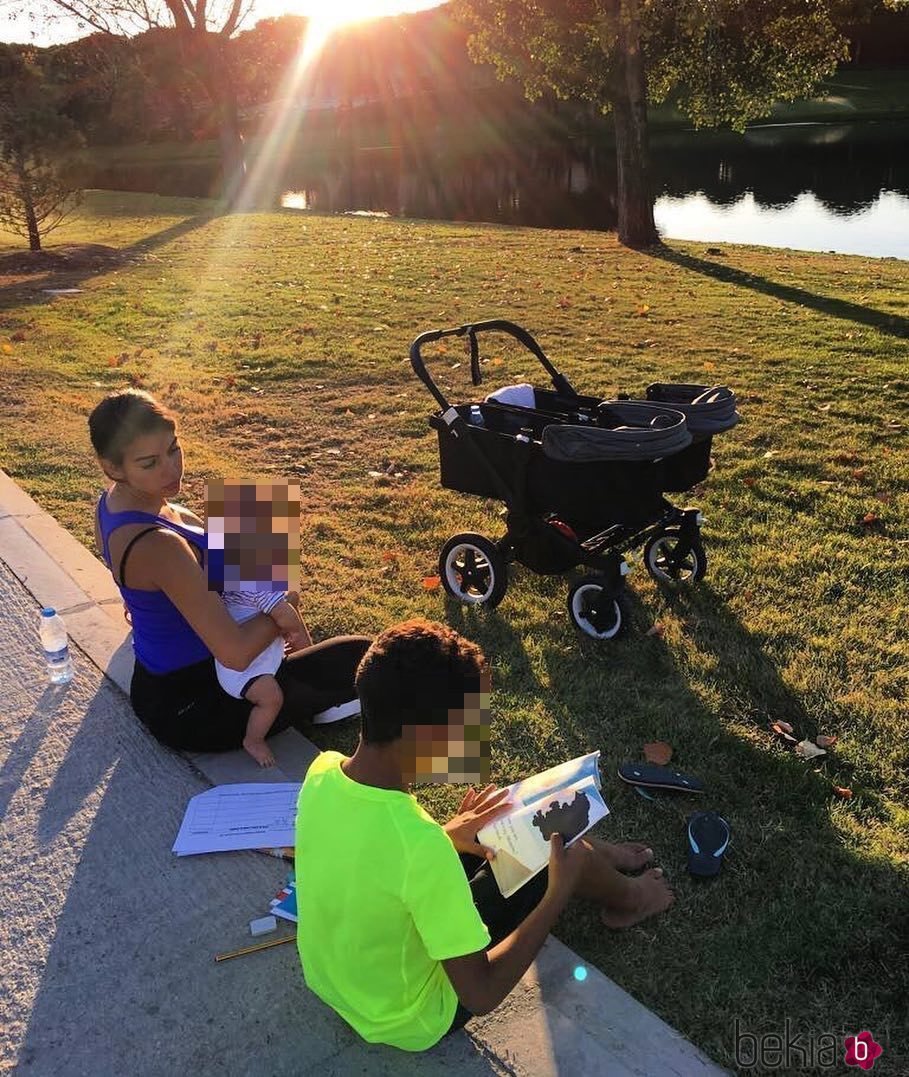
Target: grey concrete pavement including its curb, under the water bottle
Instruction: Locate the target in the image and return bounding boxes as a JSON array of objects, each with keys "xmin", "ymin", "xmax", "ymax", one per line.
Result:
[{"xmin": 0, "ymin": 473, "xmax": 724, "ymax": 1077}]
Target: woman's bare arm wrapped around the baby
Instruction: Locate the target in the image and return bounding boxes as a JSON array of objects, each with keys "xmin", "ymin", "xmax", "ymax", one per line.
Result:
[{"xmin": 148, "ymin": 531, "xmax": 280, "ymax": 670}]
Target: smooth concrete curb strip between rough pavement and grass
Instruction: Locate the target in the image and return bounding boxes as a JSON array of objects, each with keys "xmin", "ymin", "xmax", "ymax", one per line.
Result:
[{"xmin": 0, "ymin": 471, "xmax": 726, "ymax": 1077}]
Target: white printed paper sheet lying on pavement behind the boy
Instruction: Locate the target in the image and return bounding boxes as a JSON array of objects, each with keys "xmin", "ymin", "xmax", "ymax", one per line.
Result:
[{"xmin": 172, "ymin": 782, "xmax": 302, "ymax": 856}]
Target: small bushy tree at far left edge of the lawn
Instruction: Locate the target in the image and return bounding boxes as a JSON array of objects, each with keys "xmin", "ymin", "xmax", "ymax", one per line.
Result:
[{"xmin": 0, "ymin": 44, "xmax": 82, "ymax": 251}]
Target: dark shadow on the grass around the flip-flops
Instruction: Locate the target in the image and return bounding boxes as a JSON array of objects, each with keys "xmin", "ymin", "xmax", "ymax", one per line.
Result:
[{"xmin": 525, "ymin": 587, "xmax": 909, "ymax": 1073}]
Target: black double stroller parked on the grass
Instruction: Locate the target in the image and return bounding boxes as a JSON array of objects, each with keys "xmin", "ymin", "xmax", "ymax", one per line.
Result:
[{"xmin": 410, "ymin": 320, "xmax": 739, "ymax": 640}]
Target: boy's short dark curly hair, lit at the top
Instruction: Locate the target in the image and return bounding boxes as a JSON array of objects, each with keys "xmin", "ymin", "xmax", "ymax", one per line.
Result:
[{"xmin": 356, "ymin": 617, "xmax": 486, "ymax": 744}]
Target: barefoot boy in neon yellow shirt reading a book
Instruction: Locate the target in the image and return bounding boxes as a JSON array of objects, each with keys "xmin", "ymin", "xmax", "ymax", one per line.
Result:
[{"xmin": 296, "ymin": 620, "xmax": 672, "ymax": 1051}]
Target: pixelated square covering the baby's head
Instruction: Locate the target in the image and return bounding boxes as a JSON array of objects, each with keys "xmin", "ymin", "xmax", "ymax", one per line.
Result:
[{"xmin": 205, "ymin": 479, "xmax": 299, "ymax": 591}]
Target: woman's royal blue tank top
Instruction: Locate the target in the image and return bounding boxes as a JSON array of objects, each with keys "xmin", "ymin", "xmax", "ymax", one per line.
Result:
[{"xmin": 98, "ymin": 493, "xmax": 211, "ymax": 674}]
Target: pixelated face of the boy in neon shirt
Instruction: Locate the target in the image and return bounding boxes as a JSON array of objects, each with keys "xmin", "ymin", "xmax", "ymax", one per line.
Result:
[{"xmin": 401, "ymin": 671, "xmax": 490, "ymax": 784}]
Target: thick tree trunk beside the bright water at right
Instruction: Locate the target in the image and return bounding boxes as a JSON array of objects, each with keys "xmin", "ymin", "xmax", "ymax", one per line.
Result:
[{"xmin": 613, "ymin": 0, "xmax": 659, "ymax": 250}]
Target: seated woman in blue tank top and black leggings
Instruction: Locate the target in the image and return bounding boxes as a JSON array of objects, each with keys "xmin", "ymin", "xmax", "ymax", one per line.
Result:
[{"xmin": 88, "ymin": 389, "xmax": 369, "ymax": 752}]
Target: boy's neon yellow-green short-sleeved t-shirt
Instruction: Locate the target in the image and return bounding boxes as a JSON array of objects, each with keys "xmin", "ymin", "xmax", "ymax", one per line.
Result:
[{"xmin": 295, "ymin": 752, "xmax": 489, "ymax": 1051}]
